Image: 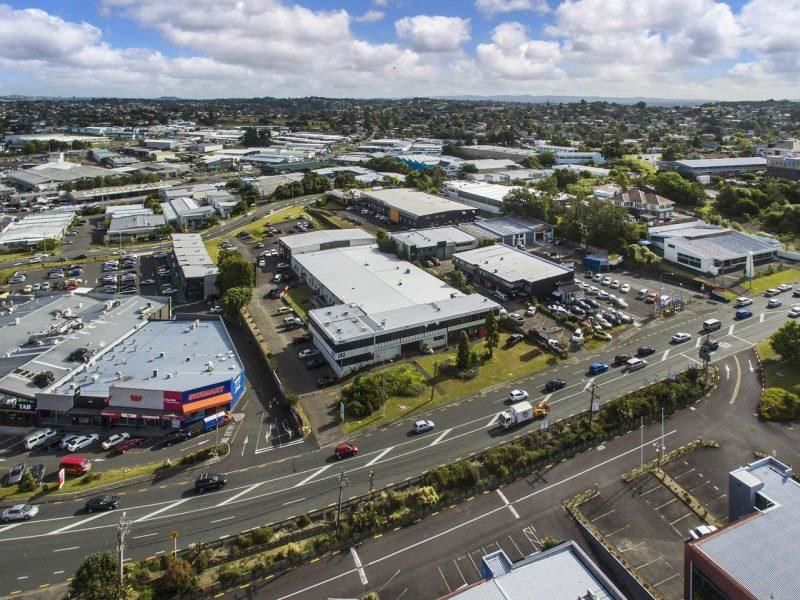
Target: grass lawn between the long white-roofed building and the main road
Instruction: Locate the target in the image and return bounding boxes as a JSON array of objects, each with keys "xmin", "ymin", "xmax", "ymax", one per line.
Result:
[{"xmin": 342, "ymin": 333, "xmax": 558, "ymax": 433}]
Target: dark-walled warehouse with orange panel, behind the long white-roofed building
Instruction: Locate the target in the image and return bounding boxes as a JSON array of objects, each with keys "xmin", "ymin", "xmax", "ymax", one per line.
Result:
[{"xmin": 356, "ymin": 188, "xmax": 478, "ymax": 228}]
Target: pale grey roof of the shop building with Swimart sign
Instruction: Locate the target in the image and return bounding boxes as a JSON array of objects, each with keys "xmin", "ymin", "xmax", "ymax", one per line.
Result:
[{"xmin": 54, "ymin": 319, "xmax": 244, "ymax": 397}]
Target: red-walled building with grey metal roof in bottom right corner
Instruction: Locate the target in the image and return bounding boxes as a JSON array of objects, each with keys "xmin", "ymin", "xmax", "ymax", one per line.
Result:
[{"xmin": 683, "ymin": 457, "xmax": 800, "ymax": 600}]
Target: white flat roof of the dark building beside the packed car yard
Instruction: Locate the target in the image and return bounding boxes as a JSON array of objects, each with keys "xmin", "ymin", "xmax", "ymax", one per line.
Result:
[{"xmin": 453, "ymin": 244, "xmax": 570, "ymax": 282}]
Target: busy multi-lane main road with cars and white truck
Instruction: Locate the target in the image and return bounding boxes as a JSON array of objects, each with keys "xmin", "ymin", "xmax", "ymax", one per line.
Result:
[{"xmin": 0, "ymin": 288, "xmax": 789, "ymax": 594}]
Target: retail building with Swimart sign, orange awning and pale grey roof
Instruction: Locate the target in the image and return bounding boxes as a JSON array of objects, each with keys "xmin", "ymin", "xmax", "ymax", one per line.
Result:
[{"xmin": 37, "ymin": 318, "xmax": 245, "ymax": 427}]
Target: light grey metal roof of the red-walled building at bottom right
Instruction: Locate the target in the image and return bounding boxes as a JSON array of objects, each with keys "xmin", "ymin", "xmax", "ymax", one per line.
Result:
[{"xmin": 692, "ymin": 458, "xmax": 800, "ymax": 598}]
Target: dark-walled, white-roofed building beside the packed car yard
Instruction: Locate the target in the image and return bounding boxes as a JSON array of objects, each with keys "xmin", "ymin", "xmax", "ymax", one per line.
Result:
[{"xmin": 453, "ymin": 244, "xmax": 575, "ymax": 299}]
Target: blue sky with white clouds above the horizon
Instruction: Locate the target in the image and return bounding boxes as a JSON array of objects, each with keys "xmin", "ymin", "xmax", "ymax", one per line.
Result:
[{"xmin": 0, "ymin": 0, "xmax": 800, "ymax": 100}]
